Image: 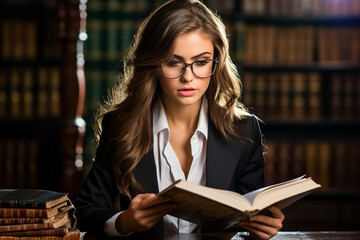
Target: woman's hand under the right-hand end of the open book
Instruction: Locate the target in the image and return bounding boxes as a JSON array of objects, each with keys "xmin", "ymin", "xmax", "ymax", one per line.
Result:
[{"xmin": 239, "ymin": 206, "xmax": 285, "ymax": 240}]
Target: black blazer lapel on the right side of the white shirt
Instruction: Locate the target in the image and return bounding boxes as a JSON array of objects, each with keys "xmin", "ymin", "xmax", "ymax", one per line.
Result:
[{"xmin": 206, "ymin": 117, "xmax": 241, "ymax": 189}]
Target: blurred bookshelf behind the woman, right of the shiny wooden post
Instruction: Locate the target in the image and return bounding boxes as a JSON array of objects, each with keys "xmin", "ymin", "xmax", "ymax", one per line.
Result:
[{"xmin": 84, "ymin": 0, "xmax": 360, "ymax": 230}]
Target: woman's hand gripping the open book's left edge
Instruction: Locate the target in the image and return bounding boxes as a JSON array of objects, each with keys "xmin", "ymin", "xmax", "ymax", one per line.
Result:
[{"xmin": 115, "ymin": 193, "xmax": 175, "ymax": 235}]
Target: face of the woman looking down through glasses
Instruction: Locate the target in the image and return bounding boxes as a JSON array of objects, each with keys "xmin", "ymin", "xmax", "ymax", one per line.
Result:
[{"xmin": 159, "ymin": 30, "xmax": 214, "ymax": 107}]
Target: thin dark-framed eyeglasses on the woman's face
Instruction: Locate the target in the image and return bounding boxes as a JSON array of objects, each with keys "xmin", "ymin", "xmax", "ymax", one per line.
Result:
[{"xmin": 161, "ymin": 59, "xmax": 219, "ymax": 79}]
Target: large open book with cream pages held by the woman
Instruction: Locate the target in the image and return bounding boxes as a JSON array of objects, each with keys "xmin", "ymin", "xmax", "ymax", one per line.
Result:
[{"xmin": 159, "ymin": 175, "xmax": 320, "ymax": 231}]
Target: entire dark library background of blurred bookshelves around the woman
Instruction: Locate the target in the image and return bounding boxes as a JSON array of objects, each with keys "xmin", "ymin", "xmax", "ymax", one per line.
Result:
[{"xmin": 0, "ymin": 0, "xmax": 360, "ymax": 230}]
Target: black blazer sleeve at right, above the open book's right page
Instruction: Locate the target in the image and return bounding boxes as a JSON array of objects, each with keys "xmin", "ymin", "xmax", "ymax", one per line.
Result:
[{"xmin": 235, "ymin": 115, "xmax": 265, "ymax": 194}]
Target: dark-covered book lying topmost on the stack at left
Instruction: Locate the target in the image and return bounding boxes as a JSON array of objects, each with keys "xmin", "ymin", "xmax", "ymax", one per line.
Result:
[{"xmin": 0, "ymin": 189, "xmax": 68, "ymax": 208}]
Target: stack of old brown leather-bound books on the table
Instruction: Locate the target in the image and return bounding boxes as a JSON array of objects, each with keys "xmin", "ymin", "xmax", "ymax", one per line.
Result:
[{"xmin": 0, "ymin": 189, "xmax": 80, "ymax": 240}]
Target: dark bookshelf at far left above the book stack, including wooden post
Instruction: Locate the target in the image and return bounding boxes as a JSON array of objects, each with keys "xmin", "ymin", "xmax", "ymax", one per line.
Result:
[{"xmin": 0, "ymin": 0, "xmax": 84, "ymax": 201}]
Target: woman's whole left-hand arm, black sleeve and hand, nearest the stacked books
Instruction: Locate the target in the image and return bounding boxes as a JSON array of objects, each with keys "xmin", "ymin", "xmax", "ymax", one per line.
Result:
[{"xmin": 76, "ymin": 115, "xmax": 173, "ymax": 235}]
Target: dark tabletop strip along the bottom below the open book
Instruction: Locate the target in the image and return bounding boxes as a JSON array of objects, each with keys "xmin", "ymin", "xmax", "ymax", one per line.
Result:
[{"xmin": 81, "ymin": 231, "xmax": 360, "ymax": 240}]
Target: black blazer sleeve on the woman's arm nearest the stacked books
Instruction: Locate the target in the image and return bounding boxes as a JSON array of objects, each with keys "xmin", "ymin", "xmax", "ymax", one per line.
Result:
[{"xmin": 75, "ymin": 115, "xmax": 129, "ymax": 235}]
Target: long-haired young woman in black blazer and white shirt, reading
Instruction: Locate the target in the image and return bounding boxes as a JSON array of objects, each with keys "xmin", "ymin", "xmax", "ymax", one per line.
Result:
[{"xmin": 76, "ymin": 0, "xmax": 284, "ymax": 239}]
